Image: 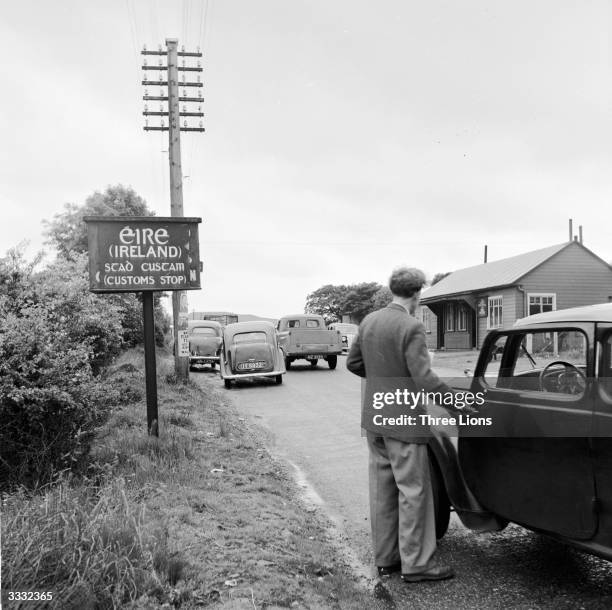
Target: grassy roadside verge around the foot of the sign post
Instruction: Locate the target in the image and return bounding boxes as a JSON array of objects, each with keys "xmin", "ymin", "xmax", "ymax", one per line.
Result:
[{"xmin": 2, "ymin": 352, "xmax": 388, "ymax": 610}]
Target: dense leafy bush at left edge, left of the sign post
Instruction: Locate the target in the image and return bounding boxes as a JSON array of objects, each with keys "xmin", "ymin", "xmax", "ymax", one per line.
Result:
[{"xmin": 0, "ymin": 249, "xmax": 121, "ymax": 488}]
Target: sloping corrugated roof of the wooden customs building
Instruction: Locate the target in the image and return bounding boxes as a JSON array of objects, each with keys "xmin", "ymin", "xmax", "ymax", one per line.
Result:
[{"xmin": 421, "ymin": 241, "xmax": 573, "ymax": 304}]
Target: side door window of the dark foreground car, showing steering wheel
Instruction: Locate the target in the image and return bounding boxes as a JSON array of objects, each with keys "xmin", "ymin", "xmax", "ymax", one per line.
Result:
[{"xmin": 485, "ymin": 330, "xmax": 588, "ymax": 398}]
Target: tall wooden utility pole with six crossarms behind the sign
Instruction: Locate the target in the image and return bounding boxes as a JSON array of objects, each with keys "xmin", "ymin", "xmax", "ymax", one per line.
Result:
[{"xmin": 142, "ymin": 38, "xmax": 204, "ymax": 380}]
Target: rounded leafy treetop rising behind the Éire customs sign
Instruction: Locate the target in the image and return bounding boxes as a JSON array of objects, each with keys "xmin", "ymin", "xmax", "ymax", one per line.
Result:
[{"xmin": 43, "ymin": 184, "xmax": 155, "ymax": 259}]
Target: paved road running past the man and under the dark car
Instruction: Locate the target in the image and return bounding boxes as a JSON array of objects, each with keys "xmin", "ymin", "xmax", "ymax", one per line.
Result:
[{"xmin": 193, "ymin": 358, "xmax": 612, "ymax": 610}]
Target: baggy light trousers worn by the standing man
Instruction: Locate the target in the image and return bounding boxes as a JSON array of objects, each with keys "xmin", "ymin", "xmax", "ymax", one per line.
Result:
[{"xmin": 367, "ymin": 432, "xmax": 436, "ymax": 574}]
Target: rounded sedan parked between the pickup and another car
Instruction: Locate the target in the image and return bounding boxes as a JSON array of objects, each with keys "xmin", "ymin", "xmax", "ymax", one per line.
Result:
[{"xmin": 220, "ymin": 321, "xmax": 286, "ymax": 389}]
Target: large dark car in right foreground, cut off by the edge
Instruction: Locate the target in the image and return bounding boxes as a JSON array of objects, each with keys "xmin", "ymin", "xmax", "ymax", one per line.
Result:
[{"xmin": 430, "ymin": 303, "xmax": 612, "ymax": 560}]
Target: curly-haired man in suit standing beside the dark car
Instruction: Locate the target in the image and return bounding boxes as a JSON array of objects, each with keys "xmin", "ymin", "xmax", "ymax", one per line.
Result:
[{"xmin": 346, "ymin": 267, "xmax": 454, "ymax": 582}]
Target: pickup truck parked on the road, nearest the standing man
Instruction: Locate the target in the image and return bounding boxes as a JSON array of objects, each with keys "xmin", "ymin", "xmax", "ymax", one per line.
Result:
[{"xmin": 276, "ymin": 314, "xmax": 342, "ymax": 370}]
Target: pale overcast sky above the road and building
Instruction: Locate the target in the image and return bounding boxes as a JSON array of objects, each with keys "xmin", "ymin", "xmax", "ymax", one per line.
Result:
[{"xmin": 0, "ymin": 0, "xmax": 612, "ymax": 317}]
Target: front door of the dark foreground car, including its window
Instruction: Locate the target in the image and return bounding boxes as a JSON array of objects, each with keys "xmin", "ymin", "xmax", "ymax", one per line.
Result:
[{"xmin": 459, "ymin": 324, "xmax": 597, "ymax": 540}]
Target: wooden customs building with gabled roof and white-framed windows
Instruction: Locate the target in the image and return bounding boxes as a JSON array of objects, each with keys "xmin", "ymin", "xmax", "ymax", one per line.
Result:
[{"xmin": 419, "ymin": 241, "xmax": 612, "ymax": 349}]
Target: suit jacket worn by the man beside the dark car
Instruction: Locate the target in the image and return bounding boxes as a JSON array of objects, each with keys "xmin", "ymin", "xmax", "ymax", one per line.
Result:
[{"xmin": 346, "ymin": 303, "xmax": 452, "ymax": 443}]
